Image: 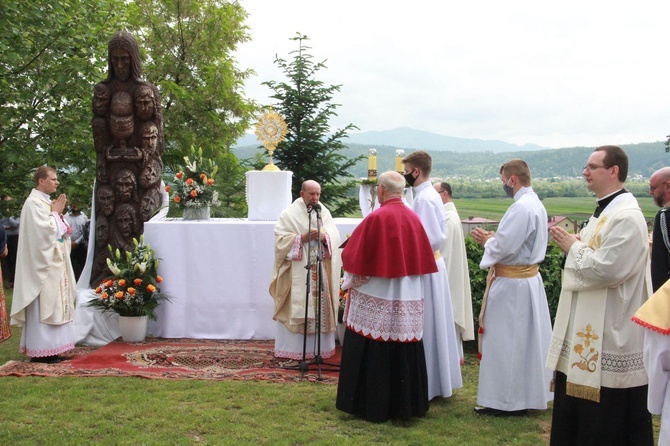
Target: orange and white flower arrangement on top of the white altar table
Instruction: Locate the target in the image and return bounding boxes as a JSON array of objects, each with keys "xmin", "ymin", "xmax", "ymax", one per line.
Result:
[{"xmin": 165, "ymin": 147, "xmax": 220, "ymax": 209}]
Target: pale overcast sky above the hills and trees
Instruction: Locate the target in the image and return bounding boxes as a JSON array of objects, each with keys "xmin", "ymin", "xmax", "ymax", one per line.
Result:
[{"xmin": 236, "ymin": 0, "xmax": 670, "ymax": 148}]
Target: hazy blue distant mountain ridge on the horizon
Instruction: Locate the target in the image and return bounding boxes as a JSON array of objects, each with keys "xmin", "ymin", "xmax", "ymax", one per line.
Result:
[{"xmin": 237, "ymin": 127, "xmax": 547, "ymax": 153}]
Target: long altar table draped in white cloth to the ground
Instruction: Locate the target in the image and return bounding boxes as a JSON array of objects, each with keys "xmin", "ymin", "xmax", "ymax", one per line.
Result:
[{"xmin": 144, "ymin": 218, "xmax": 361, "ymax": 339}]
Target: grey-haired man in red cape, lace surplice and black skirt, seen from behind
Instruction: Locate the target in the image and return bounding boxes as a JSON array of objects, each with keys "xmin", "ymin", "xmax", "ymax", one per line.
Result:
[{"xmin": 336, "ymin": 172, "xmax": 437, "ymax": 422}]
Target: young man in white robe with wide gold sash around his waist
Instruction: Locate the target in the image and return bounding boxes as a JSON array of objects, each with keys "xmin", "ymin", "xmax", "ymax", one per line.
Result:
[{"xmin": 472, "ymin": 159, "xmax": 552, "ymax": 415}]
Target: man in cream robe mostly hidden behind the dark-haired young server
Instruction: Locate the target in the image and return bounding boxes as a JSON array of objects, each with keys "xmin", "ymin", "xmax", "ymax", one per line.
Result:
[{"xmin": 433, "ymin": 181, "xmax": 475, "ymax": 364}]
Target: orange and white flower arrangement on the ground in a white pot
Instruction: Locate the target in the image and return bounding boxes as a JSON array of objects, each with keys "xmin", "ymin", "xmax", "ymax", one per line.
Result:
[{"xmin": 89, "ymin": 236, "xmax": 168, "ymax": 320}]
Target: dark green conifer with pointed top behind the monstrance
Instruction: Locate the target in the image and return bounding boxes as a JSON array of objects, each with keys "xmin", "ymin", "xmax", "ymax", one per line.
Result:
[{"xmin": 263, "ymin": 34, "xmax": 368, "ymax": 216}]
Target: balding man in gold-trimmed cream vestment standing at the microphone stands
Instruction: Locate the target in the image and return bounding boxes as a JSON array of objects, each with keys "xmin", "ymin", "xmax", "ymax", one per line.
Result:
[{"xmin": 270, "ymin": 180, "xmax": 342, "ymax": 365}]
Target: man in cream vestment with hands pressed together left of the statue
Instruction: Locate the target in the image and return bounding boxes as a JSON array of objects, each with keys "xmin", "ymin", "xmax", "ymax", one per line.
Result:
[{"xmin": 11, "ymin": 166, "xmax": 77, "ymax": 363}]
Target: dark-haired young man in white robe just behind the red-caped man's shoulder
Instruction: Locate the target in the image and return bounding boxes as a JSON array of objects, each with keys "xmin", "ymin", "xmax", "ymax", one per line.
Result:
[{"xmin": 402, "ymin": 150, "xmax": 463, "ymax": 399}]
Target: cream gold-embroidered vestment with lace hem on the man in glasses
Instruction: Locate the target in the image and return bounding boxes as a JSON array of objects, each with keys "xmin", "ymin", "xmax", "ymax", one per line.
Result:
[{"xmin": 547, "ymin": 193, "xmax": 651, "ymax": 401}]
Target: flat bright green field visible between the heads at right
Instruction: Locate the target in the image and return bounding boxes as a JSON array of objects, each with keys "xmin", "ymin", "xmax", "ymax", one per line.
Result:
[{"xmin": 454, "ymin": 197, "xmax": 658, "ymax": 221}]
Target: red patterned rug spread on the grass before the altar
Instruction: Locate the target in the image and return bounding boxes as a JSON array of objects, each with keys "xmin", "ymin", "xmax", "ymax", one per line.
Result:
[{"xmin": 0, "ymin": 338, "xmax": 341, "ymax": 384}]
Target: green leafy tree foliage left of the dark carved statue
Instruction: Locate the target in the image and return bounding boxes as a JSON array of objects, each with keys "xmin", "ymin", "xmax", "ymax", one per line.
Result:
[{"xmin": 0, "ymin": 0, "xmax": 124, "ymax": 213}]
